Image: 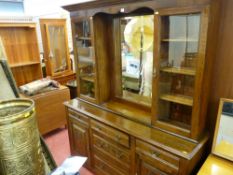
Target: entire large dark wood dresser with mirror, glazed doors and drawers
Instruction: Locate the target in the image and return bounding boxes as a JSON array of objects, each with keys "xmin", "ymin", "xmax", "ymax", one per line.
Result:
[{"xmin": 63, "ymin": 0, "xmax": 219, "ymax": 175}]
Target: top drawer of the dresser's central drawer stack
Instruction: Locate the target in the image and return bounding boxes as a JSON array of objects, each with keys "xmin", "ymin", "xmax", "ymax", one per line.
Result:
[{"xmin": 91, "ymin": 120, "xmax": 129, "ymax": 148}]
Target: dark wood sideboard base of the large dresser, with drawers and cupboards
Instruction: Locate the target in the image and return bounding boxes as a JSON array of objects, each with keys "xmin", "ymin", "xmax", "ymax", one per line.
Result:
[{"xmin": 65, "ymin": 99, "xmax": 208, "ymax": 175}]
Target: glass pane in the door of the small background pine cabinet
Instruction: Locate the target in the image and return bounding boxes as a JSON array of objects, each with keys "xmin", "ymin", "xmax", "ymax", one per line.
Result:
[{"xmin": 48, "ymin": 25, "xmax": 68, "ymax": 74}]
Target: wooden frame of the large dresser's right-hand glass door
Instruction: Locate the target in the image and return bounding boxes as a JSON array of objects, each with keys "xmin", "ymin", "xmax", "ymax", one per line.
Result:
[{"xmin": 152, "ymin": 6, "xmax": 212, "ymax": 140}]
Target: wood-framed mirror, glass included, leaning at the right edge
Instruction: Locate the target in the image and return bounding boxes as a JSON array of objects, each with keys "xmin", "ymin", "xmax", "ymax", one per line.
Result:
[{"xmin": 212, "ymin": 99, "xmax": 233, "ymax": 161}]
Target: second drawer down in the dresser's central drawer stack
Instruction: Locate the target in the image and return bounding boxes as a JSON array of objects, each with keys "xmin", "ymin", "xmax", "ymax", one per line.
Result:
[{"xmin": 93, "ymin": 134, "xmax": 130, "ymax": 164}]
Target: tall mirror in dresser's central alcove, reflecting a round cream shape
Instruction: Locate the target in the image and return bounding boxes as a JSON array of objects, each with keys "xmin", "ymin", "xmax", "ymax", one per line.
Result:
[{"xmin": 120, "ymin": 15, "xmax": 154, "ymax": 106}]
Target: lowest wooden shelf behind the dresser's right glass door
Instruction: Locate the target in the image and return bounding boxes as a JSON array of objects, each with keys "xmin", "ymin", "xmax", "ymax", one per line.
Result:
[{"xmin": 160, "ymin": 94, "xmax": 193, "ymax": 106}]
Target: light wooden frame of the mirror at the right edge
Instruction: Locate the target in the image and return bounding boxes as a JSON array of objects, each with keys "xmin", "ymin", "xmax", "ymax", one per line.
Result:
[{"xmin": 212, "ymin": 98, "xmax": 233, "ymax": 161}]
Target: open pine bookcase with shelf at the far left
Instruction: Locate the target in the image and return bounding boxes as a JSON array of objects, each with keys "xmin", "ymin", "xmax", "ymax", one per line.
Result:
[{"xmin": 0, "ymin": 22, "xmax": 42, "ymax": 86}]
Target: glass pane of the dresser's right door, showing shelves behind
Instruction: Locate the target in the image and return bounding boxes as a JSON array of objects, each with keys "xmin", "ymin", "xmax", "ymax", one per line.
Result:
[{"xmin": 158, "ymin": 14, "xmax": 200, "ymax": 129}]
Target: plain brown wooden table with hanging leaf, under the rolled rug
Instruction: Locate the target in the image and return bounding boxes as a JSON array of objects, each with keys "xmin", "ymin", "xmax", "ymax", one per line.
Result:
[{"xmin": 24, "ymin": 86, "xmax": 70, "ymax": 135}]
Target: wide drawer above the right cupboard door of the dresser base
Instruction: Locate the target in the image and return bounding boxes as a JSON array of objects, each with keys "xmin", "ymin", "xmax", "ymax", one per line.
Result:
[{"xmin": 136, "ymin": 140, "xmax": 180, "ymax": 175}]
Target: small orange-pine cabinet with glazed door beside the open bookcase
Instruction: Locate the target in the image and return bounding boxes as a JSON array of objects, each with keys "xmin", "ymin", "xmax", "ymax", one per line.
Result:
[{"xmin": 40, "ymin": 19, "xmax": 75, "ymax": 84}]
